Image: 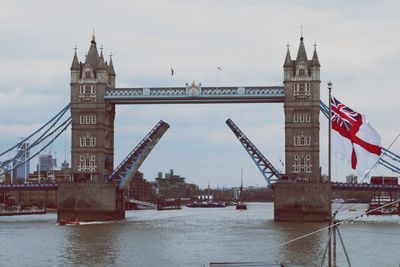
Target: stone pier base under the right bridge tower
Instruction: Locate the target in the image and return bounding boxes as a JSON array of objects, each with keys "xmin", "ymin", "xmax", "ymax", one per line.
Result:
[{"xmin": 272, "ymin": 182, "xmax": 331, "ymax": 222}]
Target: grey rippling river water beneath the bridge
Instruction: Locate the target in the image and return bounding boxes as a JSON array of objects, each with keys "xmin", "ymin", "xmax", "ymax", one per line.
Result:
[{"xmin": 0, "ymin": 203, "xmax": 400, "ymax": 267}]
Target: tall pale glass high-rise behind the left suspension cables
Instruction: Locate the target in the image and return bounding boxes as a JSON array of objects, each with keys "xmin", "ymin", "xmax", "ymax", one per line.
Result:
[{"xmin": 13, "ymin": 143, "xmax": 30, "ymax": 183}]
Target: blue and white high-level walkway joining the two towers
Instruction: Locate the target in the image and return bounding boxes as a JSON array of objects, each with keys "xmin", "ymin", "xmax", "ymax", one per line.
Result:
[{"xmin": 104, "ymin": 86, "xmax": 285, "ymax": 104}]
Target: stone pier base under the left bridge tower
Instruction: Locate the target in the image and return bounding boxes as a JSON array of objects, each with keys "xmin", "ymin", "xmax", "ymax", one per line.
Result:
[{"xmin": 57, "ymin": 183, "xmax": 125, "ymax": 222}]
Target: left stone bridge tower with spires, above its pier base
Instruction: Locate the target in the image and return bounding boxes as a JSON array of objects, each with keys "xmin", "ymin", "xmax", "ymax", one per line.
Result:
[{"xmin": 71, "ymin": 35, "xmax": 115, "ymax": 181}]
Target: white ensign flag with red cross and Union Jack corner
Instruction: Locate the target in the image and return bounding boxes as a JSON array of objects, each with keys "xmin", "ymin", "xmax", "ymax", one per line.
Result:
[{"xmin": 331, "ymin": 97, "xmax": 381, "ymax": 177}]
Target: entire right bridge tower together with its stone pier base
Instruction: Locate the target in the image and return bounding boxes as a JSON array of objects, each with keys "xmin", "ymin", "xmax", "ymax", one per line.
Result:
[{"xmin": 273, "ymin": 36, "xmax": 331, "ymax": 221}]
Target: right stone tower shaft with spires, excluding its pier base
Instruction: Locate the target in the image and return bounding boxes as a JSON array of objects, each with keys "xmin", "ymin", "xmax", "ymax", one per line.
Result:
[{"xmin": 283, "ymin": 37, "xmax": 321, "ymax": 182}]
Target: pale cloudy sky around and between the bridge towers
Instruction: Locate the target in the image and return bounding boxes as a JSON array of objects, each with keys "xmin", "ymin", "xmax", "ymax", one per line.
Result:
[{"xmin": 0, "ymin": 0, "xmax": 400, "ymax": 188}]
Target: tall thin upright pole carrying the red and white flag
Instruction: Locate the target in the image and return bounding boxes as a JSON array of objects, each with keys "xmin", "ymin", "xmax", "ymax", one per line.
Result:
[{"xmin": 328, "ymin": 81, "xmax": 332, "ymax": 267}]
